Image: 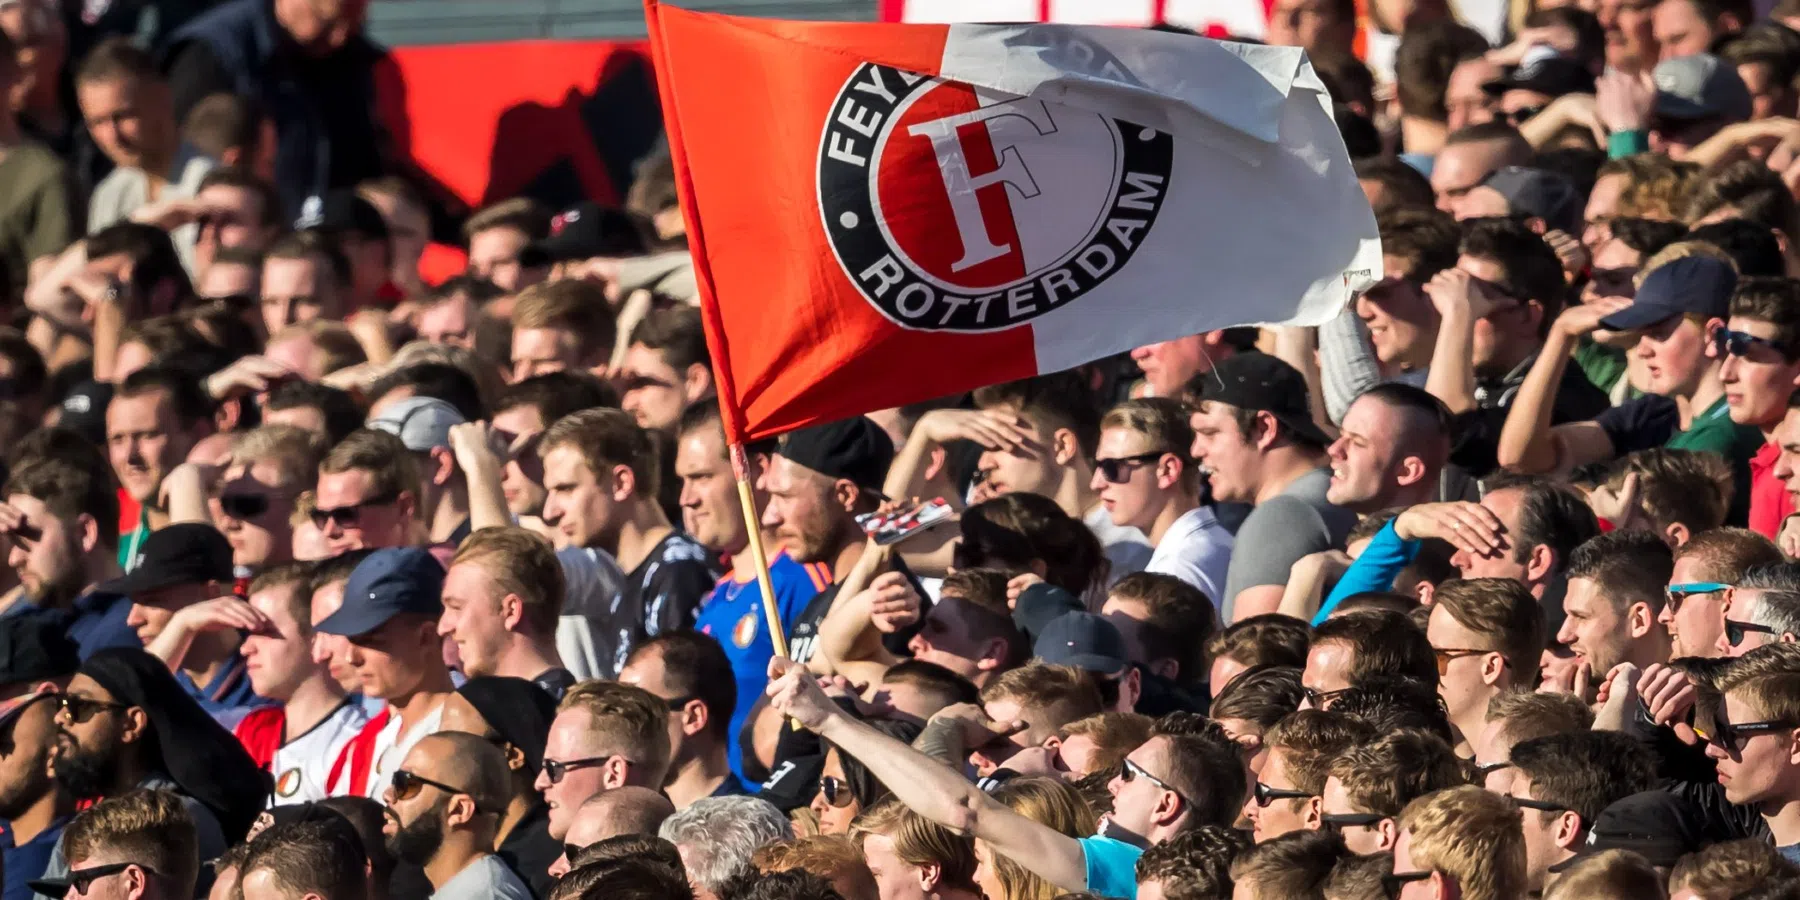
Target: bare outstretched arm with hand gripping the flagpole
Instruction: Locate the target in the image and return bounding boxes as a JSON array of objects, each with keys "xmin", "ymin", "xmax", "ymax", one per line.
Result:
[{"xmin": 769, "ymin": 657, "xmax": 1087, "ymax": 891}]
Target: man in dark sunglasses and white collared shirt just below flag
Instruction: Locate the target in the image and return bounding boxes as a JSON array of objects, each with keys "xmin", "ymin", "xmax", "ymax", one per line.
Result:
[{"xmin": 1089, "ymin": 399, "xmax": 1231, "ymax": 598}]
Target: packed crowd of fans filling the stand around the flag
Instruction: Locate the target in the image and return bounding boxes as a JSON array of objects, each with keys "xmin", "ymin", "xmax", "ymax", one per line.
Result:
[{"xmin": 14, "ymin": 0, "xmax": 1800, "ymax": 900}]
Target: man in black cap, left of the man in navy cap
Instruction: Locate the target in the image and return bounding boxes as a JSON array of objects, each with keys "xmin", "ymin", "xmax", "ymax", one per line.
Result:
[{"xmin": 101, "ymin": 522, "xmax": 268, "ymax": 725}]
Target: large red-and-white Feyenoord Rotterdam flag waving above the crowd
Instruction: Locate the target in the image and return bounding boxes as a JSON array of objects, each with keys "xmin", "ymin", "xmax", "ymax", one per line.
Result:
[{"xmin": 644, "ymin": 0, "xmax": 1381, "ymax": 441}]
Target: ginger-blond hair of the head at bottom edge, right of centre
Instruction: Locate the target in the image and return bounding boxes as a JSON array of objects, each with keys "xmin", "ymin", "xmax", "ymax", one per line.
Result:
[{"xmin": 1400, "ymin": 785, "xmax": 1525, "ymax": 900}]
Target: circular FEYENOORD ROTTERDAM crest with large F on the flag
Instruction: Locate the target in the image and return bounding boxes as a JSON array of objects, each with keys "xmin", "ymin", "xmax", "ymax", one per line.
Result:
[{"xmin": 819, "ymin": 63, "xmax": 1174, "ymax": 331}]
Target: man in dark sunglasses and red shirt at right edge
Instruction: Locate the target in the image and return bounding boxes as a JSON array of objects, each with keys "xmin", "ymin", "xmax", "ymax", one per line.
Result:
[{"xmin": 1712, "ymin": 277, "xmax": 1800, "ymax": 540}]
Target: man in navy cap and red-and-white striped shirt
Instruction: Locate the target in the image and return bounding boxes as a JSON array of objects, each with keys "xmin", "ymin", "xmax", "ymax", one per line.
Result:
[{"xmin": 315, "ymin": 547, "xmax": 454, "ymax": 799}]
